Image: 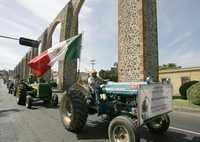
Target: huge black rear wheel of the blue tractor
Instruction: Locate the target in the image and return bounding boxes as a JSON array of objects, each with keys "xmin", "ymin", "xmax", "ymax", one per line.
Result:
[{"xmin": 60, "ymin": 89, "xmax": 88, "ymax": 133}]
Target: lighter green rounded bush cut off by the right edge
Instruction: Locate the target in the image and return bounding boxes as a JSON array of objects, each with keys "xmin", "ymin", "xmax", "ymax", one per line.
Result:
[{"xmin": 187, "ymin": 82, "xmax": 200, "ymax": 105}]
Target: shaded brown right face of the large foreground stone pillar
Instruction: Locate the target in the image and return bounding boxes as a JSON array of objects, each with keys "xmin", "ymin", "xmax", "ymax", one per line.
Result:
[{"xmin": 143, "ymin": 0, "xmax": 159, "ymax": 81}]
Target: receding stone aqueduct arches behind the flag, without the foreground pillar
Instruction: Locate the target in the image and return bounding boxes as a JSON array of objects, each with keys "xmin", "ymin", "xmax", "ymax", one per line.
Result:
[{"xmin": 14, "ymin": 0, "xmax": 85, "ymax": 89}]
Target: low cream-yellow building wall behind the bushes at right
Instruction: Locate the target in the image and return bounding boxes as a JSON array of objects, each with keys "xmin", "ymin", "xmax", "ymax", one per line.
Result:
[{"xmin": 159, "ymin": 67, "xmax": 200, "ymax": 95}]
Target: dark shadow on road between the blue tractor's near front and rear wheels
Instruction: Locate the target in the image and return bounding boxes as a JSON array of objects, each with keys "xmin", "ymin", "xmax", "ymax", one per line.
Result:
[{"xmin": 77, "ymin": 117, "xmax": 109, "ymax": 140}]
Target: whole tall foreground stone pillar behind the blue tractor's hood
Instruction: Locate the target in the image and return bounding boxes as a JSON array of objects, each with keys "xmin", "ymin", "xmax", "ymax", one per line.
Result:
[{"xmin": 118, "ymin": 0, "xmax": 158, "ymax": 81}]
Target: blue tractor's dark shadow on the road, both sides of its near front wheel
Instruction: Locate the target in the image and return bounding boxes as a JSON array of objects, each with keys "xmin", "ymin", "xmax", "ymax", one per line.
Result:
[{"xmin": 77, "ymin": 117, "xmax": 200, "ymax": 142}]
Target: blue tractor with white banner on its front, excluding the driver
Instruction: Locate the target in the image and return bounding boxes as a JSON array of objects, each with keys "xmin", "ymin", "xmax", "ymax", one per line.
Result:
[{"xmin": 60, "ymin": 81, "xmax": 172, "ymax": 142}]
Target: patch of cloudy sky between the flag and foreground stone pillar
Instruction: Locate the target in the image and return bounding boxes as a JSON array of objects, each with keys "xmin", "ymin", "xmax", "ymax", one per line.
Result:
[{"xmin": 79, "ymin": 0, "xmax": 117, "ymax": 72}]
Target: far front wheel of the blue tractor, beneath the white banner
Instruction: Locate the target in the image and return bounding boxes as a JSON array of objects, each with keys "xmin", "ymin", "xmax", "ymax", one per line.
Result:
[{"xmin": 147, "ymin": 114, "xmax": 170, "ymax": 134}]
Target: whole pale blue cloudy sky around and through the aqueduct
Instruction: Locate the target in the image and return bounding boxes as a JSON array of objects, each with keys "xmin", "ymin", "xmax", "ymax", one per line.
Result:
[{"xmin": 0, "ymin": 0, "xmax": 200, "ymax": 70}]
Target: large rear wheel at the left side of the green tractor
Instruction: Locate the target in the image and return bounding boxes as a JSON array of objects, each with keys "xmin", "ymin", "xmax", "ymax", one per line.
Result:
[{"xmin": 17, "ymin": 86, "xmax": 26, "ymax": 105}]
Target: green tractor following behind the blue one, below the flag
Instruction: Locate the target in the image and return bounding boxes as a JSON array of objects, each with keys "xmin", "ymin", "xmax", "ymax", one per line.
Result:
[{"xmin": 16, "ymin": 76, "xmax": 58, "ymax": 109}]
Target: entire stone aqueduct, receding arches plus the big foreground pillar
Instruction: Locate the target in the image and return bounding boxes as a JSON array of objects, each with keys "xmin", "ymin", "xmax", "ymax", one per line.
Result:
[{"xmin": 15, "ymin": 0, "xmax": 158, "ymax": 89}]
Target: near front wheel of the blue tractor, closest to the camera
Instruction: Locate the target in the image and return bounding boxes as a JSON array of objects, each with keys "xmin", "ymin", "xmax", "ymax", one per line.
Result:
[{"xmin": 108, "ymin": 116, "xmax": 140, "ymax": 142}]
